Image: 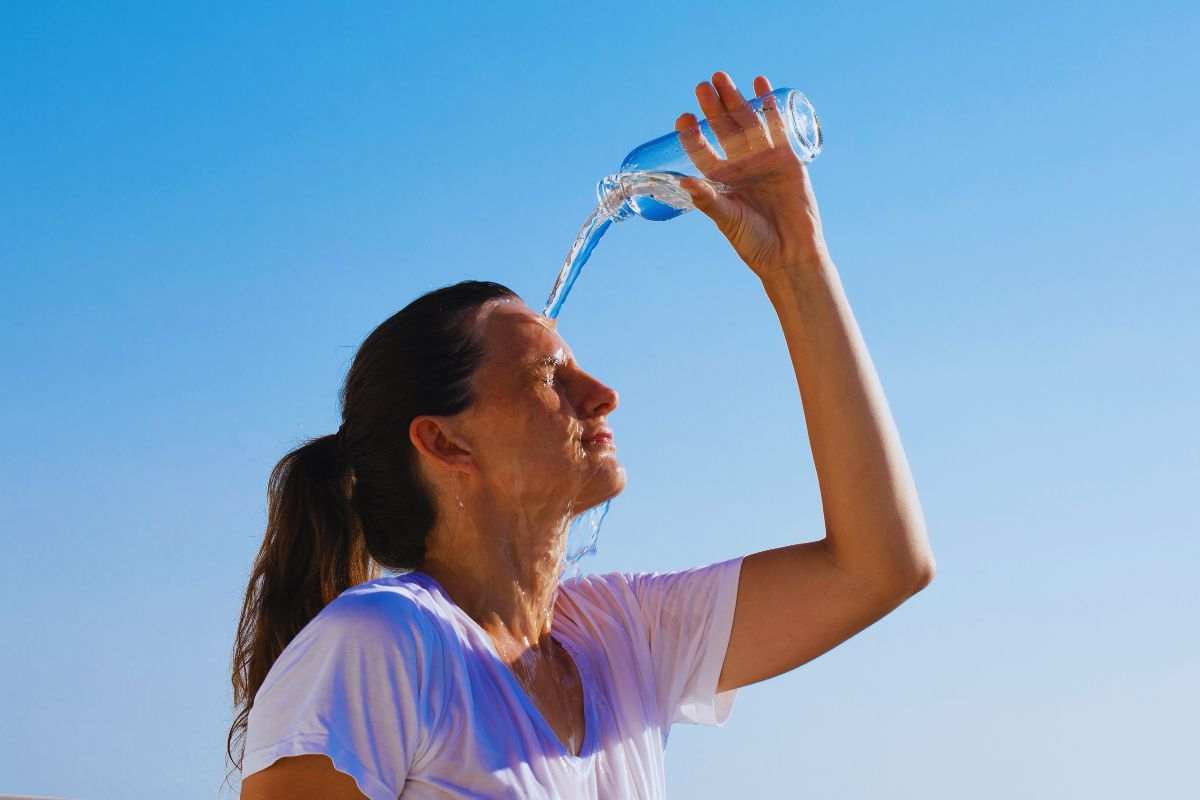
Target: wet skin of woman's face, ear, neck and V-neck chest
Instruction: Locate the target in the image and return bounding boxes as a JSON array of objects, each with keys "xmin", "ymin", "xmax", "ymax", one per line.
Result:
[{"xmin": 409, "ymin": 301, "xmax": 625, "ymax": 753}]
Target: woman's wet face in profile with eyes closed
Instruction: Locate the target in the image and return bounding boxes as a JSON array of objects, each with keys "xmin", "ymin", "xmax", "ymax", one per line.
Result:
[{"xmin": 451, "ymin": 300, "xmax": 625, "ymax": 517}]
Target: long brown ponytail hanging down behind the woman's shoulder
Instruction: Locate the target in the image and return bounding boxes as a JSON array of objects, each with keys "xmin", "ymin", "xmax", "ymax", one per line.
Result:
[{"xmin": 226, "ymin": 432, "xmax": 377, "ymax": 770}]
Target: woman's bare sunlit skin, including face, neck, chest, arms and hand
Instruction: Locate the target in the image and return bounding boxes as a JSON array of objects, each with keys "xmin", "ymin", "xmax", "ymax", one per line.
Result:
[{"xmin": 242, "ymin": 72, "xmax": 935, "ymax": 800}]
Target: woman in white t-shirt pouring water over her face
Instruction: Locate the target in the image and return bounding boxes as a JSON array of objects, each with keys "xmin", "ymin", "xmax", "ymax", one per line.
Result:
[{"xmin": 229, "ymin": 72, "xmax": 934, "ymax": 800}]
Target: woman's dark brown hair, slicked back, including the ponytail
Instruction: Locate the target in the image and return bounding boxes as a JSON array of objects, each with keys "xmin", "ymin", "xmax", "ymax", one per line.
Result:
[{"xmin": 226, "ymin": 281, "xmax": 517, "ymax": 770}]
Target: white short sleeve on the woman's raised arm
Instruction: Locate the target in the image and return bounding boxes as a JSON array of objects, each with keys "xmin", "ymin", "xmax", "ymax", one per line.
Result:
[{"xmin": 629, "ymin": 558, "xmax": 742, "ymax": 726}]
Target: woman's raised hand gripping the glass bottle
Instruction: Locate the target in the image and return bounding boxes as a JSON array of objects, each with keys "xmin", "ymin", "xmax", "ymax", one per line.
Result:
[{"xmin": 676, "ymin": 72, "xmax": 829, "ymax": 281}]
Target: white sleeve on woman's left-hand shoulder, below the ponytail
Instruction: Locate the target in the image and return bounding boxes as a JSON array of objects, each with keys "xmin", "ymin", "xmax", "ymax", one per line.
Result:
[{"xmin": 242, "ymin": 590, "xmax": 436, "ymax": 800}]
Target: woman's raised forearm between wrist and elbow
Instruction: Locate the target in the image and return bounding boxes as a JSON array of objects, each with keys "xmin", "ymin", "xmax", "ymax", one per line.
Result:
[{"xmin": 763, "ymin": 259, "xmax": 934, "ymax": 591}]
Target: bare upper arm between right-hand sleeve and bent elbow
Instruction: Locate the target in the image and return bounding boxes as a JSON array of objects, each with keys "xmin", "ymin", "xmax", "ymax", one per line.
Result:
[{"xmin": 718, "ymin": 541, "xmax": 919, "ymax": 692}]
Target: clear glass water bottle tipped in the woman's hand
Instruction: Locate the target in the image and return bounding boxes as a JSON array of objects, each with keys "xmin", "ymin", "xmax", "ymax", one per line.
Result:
[{"xmin": 596, "ymin": 88, "xmax": 821, "ymax": 222}]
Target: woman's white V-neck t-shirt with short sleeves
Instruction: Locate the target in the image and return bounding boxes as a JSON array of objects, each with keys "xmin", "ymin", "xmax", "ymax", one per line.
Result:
[{"xmin": 242, "ymin": 558, "xmax": 742, "ymax": 800}]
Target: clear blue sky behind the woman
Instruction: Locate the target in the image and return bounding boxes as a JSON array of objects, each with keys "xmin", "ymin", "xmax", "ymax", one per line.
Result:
[{"xmin": 0, "ymin": 2, "xmax": 1200, "ymax": 800}]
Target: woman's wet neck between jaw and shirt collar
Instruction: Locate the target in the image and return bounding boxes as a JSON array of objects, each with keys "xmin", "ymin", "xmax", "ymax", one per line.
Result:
[{"xmin": 421, "ymin": 498, "xmax": 570, "ymax": 663}]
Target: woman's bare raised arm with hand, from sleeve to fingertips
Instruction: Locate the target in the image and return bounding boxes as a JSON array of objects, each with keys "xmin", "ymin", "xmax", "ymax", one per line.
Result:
[{"xmin": 676, "ymin": 72, "xmax": 934, "ymax": 691}]
